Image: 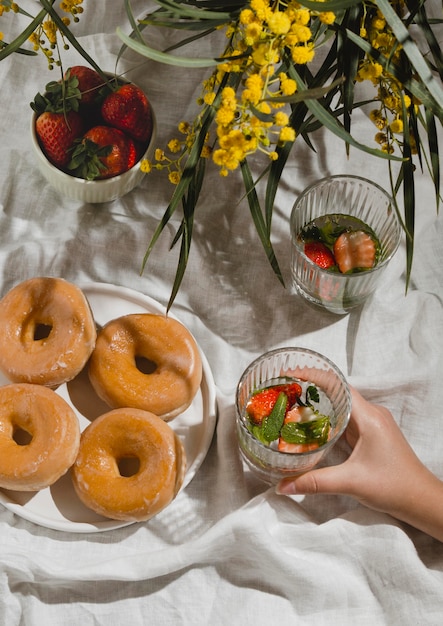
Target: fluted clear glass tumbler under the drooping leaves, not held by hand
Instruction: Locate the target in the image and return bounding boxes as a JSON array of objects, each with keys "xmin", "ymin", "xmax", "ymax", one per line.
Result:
[{"xmin": 290, "ymin": 176, "xmax": 401, "ymax": 314}]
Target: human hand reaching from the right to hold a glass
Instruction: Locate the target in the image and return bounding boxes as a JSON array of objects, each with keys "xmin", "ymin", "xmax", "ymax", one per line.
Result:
[{"xmin": 277, "ymin": 388, "xmax": 443, "ymax": 540}]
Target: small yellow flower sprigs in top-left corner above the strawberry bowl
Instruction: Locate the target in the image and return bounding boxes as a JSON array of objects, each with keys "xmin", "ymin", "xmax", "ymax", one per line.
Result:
[{"xmin": 0, "ymin": 0, "xmax": 83, "ymax": 69}]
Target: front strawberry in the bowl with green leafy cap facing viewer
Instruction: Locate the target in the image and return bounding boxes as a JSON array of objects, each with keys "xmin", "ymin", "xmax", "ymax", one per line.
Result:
[{"xmin": 68, "ymin": 126, "xmax": 137, "ymax": 180}]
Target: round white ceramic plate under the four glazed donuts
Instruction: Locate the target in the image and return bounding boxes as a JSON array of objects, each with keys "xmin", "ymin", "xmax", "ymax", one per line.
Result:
[{"xmin": 0, "ymin": 283, "xmax": 217, "ymax": 533}]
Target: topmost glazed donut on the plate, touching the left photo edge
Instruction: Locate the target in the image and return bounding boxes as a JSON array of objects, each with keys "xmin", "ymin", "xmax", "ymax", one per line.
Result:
[{"xmin": 0, "ymin": 278, "xmax": 97, "ymax": 388}]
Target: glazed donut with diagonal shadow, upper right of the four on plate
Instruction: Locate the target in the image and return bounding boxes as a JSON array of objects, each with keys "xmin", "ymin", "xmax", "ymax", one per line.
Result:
[{"xmin": 89, "ymin": 313, "xmax": 202, "ymax": 421}]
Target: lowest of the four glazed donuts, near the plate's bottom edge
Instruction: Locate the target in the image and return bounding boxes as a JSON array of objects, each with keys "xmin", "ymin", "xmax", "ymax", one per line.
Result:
[{"xmin": 71, "ymin": 408, "xmax": 186, "ymax": 522}]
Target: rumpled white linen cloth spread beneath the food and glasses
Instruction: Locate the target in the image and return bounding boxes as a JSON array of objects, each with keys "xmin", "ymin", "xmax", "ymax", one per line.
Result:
[{"xmin": 0, "ymin": 0, "xmax": 443, "ymax": 626}]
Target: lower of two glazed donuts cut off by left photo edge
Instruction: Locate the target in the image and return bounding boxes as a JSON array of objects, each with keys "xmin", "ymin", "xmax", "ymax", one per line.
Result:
[{"xmin": 0, "ymin": 383, "xmax": 80, "ymax": 491}]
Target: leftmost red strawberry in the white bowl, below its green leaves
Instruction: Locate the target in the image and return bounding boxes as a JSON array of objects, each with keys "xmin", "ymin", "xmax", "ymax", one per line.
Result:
[{"xmin": 35, "ymin": 111, "xmax": 83, "ymax": 169}]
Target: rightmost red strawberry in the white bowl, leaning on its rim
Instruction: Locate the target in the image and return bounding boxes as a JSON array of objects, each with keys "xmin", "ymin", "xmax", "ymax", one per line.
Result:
[{"xmin": 101, "ymin": 83, "xmax": 152, "ymax": 143}]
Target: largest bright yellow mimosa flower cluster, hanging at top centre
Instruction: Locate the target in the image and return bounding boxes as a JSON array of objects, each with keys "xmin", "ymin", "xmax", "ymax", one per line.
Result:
[{"xmin": 144, "ymin": 0, "xmax": 335, "ymax": 182}]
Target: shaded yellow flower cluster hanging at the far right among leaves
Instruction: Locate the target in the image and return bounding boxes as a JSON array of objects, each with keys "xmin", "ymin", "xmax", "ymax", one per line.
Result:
[{"xmin": 357, "ymin": 0, "xmax": 417, "ymax": 154}]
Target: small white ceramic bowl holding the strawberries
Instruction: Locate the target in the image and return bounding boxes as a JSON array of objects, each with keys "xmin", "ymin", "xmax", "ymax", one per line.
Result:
[{"xmin": 31, "ymin": 91, "xmax": 156, "ymax": 204}]
